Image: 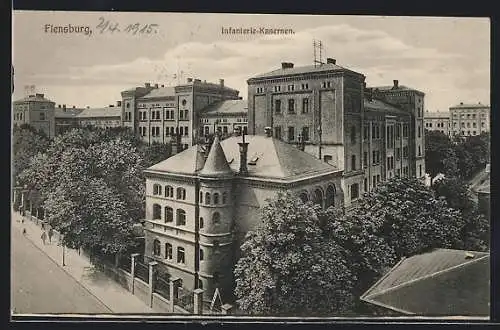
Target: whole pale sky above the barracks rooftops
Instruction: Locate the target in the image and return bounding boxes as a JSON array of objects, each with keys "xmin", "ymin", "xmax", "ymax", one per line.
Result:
[{"xmin": 12, "ymin": 11, "xmax": 490, "ymax": 111}]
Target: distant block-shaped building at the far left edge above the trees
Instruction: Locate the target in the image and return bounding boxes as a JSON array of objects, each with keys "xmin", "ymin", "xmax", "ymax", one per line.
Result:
[{"xmin": 13, "ymin": 93, "xmax": 56, "ymax": 138}]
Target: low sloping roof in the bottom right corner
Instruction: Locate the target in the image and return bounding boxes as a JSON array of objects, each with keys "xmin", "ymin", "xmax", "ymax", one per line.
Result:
[{"xmin": 360, "ymin": 249, "xmax": 490, "ymax": 317}]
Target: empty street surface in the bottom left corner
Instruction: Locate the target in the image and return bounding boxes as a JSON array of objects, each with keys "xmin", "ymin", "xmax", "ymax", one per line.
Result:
[{"xmin": 11, "ymin": 226, "xmax": 111, "ymax": 314}]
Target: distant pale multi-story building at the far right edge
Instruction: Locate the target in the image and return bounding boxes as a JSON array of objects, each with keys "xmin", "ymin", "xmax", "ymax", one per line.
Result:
[{"xmin": 450, "ymin": 102, "xmax": 490, "ymax": 136}]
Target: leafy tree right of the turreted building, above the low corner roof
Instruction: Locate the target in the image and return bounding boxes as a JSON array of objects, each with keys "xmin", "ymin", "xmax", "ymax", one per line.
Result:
[{"xmin": 355, "ymin": 177, "xmax": 463, "ymax": 259}]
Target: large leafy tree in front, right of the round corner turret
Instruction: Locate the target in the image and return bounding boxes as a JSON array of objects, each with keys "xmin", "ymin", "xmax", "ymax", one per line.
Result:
[{"xmin": 234, "ymin": 193, "xmax": 355, "ymax": 316}]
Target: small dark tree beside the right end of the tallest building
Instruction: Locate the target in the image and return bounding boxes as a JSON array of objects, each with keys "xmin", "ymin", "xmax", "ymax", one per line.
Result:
[{"xmin": 425, "ymin": 131, "xmax": 457, "ymax": 186}]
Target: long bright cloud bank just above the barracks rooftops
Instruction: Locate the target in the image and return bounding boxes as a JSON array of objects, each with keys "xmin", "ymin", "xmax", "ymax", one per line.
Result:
[{"xmin": 22, "ymin": 24, "xmax": 489, "ymax": 111}]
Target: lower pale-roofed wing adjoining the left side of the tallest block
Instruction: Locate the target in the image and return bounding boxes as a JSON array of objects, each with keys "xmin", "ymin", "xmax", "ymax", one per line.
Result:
[{"xmin": 199, "ymin": 100, "xmax": 248, "ymax": 137}]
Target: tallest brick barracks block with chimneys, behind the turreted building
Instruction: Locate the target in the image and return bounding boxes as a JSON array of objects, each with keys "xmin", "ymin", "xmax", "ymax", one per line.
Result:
[{"xmin": 247, "ymin": 58, "xmax": 425, "ymax": 206}]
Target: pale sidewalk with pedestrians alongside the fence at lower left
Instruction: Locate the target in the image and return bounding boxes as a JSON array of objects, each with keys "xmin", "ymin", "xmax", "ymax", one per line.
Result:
[{"xmin": 11, "ymin": 211, "xmax": 154, "ymax": 314}]
